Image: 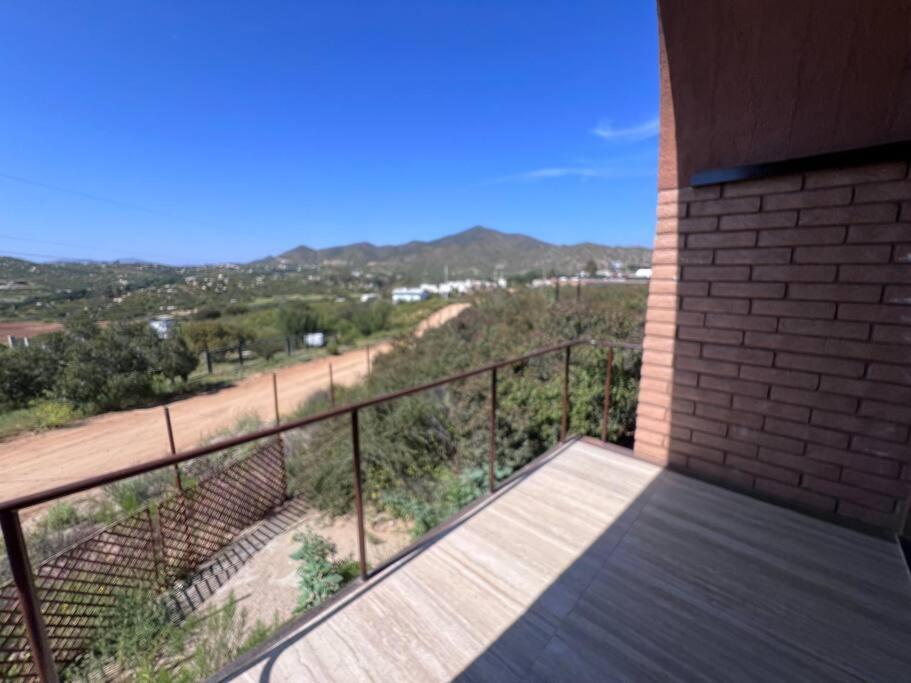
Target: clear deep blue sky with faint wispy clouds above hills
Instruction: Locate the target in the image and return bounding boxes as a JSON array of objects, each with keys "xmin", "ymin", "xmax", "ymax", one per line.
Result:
[{"xmin": 0, "ymin": 0, "xmax": 658, "ymax": 263}]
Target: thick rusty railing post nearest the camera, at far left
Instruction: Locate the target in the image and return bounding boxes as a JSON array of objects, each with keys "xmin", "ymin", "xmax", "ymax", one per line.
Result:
[{"xmin": 0, "ymin": 510, "xmax": 60, "ymax": 683}]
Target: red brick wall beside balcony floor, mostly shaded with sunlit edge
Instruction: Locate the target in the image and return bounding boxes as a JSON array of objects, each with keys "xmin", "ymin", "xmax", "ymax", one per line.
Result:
[{"xmin": 635, "ymin": 162, "xmax": 911, "ymax": 530}]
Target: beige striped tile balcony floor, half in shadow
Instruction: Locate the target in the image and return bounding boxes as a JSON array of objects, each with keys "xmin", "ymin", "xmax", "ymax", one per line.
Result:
[{"xmin": 223, "ymin": 441, "xmax": 911, "ymax": 682}]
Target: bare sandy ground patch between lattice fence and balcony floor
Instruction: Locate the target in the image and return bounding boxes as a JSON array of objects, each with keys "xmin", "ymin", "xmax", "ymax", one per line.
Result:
[{"xmin": 205, "ymin": 510, "xmax": 411, "ymax": 629}]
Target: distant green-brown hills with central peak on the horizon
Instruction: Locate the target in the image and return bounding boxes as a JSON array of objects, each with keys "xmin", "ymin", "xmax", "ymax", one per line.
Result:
[{"xmin": 268, "ymin": 226, "xmax": 651, "ymax": 279}]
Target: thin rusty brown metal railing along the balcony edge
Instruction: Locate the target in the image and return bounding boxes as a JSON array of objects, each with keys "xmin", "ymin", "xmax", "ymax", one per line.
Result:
[{"xmin": 0, "ymin": 339, "xmax": 642, "ymax": 681}]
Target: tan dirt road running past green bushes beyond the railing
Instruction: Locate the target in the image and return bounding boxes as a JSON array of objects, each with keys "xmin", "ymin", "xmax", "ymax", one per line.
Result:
[{"xmin": 0, "ymin": 304, "xmax": 468, "ymax": 500}]
